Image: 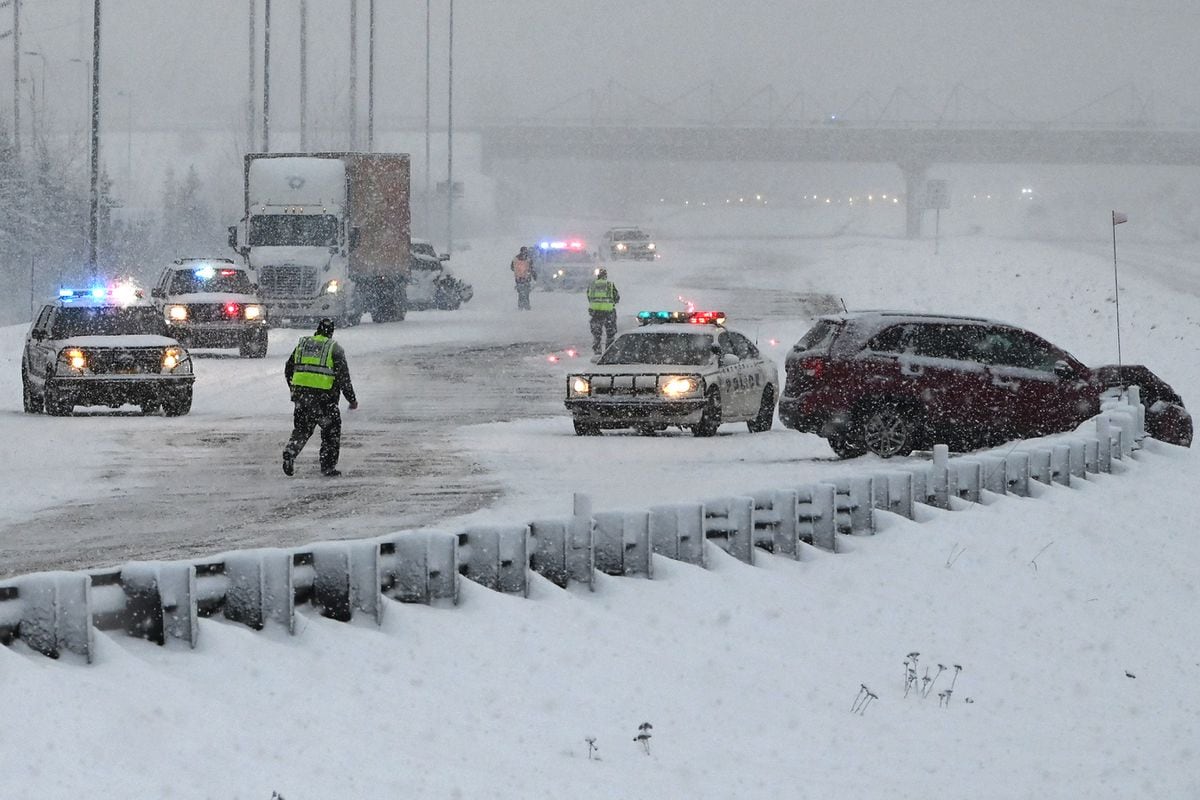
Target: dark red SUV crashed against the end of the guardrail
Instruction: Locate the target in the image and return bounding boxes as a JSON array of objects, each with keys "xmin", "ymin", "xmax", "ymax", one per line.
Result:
[{"xmin": 779, "ymin": 311, "xmax": 1161, "ymax": 458}]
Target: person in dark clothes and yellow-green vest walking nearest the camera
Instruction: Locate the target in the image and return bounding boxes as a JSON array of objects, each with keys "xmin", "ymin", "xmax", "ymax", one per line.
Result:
[{"xmin": 283, "ymin": 317, "xmax": 359, "ymax": 476}]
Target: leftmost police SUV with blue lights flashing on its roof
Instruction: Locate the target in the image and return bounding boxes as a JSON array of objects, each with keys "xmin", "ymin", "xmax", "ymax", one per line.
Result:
[{"xmin": 20, "ymin": 284, "xmax": 194, "ymax": 416}]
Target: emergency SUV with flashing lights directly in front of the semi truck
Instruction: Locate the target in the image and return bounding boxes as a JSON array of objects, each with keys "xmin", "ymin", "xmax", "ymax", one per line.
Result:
[{"xmin": 150, "ymin": 258, "xmax": 268, "ymax": 359}]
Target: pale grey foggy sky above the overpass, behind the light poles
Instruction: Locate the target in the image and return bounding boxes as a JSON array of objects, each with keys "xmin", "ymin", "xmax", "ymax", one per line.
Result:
[{"xmin": 14, "ymin": 0, "xmax": 1200, "ymax": 143}]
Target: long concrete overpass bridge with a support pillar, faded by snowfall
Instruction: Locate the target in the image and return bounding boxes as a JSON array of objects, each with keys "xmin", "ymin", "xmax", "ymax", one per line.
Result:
[{"xmin": 475, "ymin": 121, "xmax": 1200, "ymax": 237}]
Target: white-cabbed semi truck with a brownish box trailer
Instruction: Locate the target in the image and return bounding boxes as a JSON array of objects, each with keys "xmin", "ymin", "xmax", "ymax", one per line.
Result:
[{"xmin": 229, "ymin": 152, "xmax": 410, "ymax": 325}]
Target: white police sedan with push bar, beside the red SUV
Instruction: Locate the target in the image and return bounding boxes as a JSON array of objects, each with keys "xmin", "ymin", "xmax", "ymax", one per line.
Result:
[{"xmin": 566, "ymin": 311, "xmax": 779, "ymax": 437}]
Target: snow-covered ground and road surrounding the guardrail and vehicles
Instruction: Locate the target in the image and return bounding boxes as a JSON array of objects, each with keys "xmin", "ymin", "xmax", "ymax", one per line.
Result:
[{"xmin": 0, "ymin": 209, "xmax": 1200, "ymax": 800}]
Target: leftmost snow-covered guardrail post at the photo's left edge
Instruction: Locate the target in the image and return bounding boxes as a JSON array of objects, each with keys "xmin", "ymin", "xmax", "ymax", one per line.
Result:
[{"xmin": 17, "ymin": 572, "xmax": 96, "ymax": 663}]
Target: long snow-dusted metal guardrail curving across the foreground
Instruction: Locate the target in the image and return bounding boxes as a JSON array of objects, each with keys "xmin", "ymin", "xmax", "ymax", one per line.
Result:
[{"xmin": 0, "ymin": 387, "xmax": 1146, "ymax": 662}]
